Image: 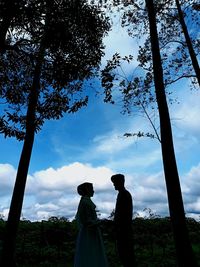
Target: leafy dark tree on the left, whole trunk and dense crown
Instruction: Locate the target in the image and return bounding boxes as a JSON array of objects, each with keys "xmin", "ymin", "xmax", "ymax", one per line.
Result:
[{"xmin": 0, "ymin": 0, "xmax": 109, "ymax": 267}]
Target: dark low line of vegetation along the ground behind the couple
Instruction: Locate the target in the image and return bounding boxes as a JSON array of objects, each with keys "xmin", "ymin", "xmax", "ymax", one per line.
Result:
[{"xmin": 0, "ymin": 217, "xmax": 200, "ymax": 267}]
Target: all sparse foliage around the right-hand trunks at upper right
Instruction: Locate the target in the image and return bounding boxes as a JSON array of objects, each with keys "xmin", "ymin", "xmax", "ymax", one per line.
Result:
[{"xmin": 102, "ymin": 0, "xmax": 200, "ymax": 117}]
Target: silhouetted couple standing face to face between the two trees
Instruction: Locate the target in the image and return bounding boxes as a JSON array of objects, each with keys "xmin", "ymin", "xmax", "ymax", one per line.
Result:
[{"xmin": 74, "ymin": 174, "xmax": 135, "ymax": 267}]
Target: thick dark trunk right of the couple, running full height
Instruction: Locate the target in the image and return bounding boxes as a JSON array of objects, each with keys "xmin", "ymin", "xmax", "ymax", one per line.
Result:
[{"xmin": 145, "ymin": 0, "xmax": 197, "ymax": 267}]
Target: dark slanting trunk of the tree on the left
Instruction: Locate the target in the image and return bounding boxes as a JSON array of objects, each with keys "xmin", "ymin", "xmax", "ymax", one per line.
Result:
[{"xmin": 0, "ymin": 48, "xmax": 44, "ymax": 267}]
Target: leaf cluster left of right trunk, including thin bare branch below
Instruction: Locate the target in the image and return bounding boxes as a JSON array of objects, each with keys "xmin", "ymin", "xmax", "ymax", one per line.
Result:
[{"xmin": 101, "ymin": 53, "xmax": 160, "ymax": 141}]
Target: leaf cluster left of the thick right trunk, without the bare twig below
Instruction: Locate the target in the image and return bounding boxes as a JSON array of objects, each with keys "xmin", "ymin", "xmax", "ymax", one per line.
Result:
[{"xmin": 101, "ymin": 53, "xmax": 155, "ymax": 113}]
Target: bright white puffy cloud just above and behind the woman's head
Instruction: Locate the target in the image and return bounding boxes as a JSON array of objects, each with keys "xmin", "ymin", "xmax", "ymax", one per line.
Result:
[{"xmin": 28, "ymin": 162, "xmax": 112, "ymax": 195}]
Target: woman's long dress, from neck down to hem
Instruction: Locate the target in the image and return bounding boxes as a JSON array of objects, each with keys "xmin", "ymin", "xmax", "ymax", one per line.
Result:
[{"xmin": 74, "ymin": 197, "xmax": 108, "ymax": 267}]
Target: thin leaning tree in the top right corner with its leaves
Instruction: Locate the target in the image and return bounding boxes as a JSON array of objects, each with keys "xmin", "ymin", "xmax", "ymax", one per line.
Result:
[{"xmin": 119, "ymin": 0, "xmax": 200, "ymax": 89}]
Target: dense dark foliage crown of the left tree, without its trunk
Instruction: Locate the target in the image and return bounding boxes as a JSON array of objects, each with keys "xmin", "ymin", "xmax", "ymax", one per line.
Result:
[{"xmin": 0, "ymin": 0, "xmax": 110, "ymax": 140}]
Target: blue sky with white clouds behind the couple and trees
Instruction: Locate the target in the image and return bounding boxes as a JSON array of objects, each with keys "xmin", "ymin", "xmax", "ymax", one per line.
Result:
[{"xmin": 0, "ymin": 13, "xmax": 200, "ymax": 221}]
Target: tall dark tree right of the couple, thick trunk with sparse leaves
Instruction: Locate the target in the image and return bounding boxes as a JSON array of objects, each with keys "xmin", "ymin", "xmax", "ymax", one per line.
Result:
[{"xmin": 102, "ymin": 0, "xmax": 197, "ymax": 267}]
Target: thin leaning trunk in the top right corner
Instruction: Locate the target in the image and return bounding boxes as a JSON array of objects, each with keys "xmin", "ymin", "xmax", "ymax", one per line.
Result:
[{"xmin": 176, "ymin": 0, "xmax": 200, "ymax": 86}]
